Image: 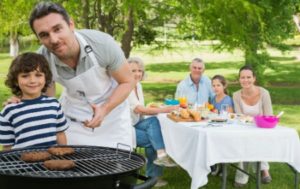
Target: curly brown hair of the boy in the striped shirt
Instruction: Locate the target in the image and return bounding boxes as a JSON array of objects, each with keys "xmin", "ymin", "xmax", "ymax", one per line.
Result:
[{"xmin": 5, "ymin": 52, "xmax": 52, "ymax": 96}]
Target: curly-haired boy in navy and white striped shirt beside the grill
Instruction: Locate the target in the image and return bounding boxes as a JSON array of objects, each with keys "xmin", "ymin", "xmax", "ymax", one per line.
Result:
[{"xmin": 0, "ymin": 53, "xmax": 68, "ymax": 150}]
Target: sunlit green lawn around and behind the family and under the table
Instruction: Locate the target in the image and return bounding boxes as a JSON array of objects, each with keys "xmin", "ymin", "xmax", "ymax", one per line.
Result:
[{"xmin": 0, "ymin": 40, "xmax": 300, "ymax": 189}]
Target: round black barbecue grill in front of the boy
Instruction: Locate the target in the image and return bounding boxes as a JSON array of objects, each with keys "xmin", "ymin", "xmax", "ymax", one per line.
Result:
[{"xmin": 0, "ymin": 145, "xmax": 156, "ymax": 189}]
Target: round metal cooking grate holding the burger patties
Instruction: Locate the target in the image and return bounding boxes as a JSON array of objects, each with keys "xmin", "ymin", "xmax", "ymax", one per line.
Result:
[{"xmin": 0, "ymin": 146, "xmax": 145, "ymax": 178}]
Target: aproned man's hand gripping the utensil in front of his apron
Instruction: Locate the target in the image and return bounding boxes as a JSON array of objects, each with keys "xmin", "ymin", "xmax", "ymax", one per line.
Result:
[{"xmin": 84, "ymin": 104, "xmax": 107, "ymax": 128}]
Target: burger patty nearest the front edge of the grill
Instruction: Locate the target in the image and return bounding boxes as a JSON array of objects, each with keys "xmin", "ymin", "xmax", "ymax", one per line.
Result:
[{"xmin": 44, "ymin": 159, "xmax": 75, "ymax": 171}]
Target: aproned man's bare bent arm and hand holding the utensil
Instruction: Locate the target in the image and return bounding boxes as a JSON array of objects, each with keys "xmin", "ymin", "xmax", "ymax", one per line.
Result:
[{"xmin": 85, "ymin": 63, "xmax": 135, "ymax": 128}]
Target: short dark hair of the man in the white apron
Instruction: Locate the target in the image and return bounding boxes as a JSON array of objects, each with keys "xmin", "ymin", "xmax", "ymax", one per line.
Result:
[{"xmin": 29, "ymin": 2, "xmax": 70, "ymax": 33}]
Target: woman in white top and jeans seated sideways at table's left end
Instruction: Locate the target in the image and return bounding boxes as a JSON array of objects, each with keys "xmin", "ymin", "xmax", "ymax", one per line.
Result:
[{"xmin": 128, "ymin": 57, "xmax": 178, "ymax": 187}]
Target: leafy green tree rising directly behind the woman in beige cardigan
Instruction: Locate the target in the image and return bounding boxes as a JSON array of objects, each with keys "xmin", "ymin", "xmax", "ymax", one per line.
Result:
[{"xmin": 177, "ymin": 0, "xmax": 298, "ymax": 81}]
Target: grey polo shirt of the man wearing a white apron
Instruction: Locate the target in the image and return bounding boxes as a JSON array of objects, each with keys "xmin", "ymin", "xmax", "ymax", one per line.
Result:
[{"xmin": 38, "ymin": 29, "xmax": 125, "ymax": 79}]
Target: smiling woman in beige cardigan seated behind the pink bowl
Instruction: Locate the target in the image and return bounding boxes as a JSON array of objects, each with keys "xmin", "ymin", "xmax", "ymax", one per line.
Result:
[{"xmin": 233, "ymin": 65, "xmax": 273, "ymax": 187}]
